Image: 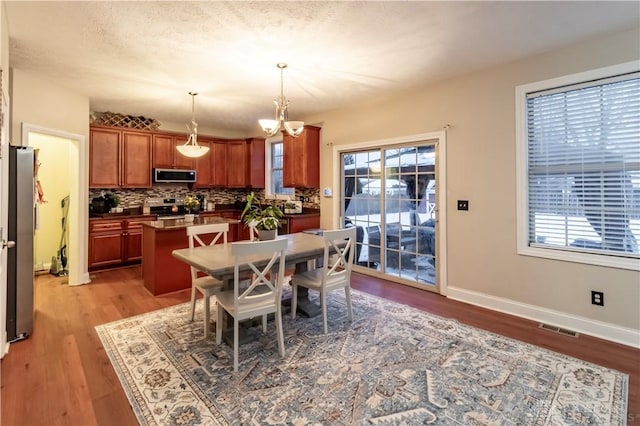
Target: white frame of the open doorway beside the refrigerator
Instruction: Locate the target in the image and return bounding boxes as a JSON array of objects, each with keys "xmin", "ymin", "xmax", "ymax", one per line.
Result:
[{"xmin": 22, "ymin": 122, "xmax": 91, "ymax": 286}]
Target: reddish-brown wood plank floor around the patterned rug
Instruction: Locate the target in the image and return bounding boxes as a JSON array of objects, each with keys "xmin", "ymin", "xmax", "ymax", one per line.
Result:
[{"xmin": 0, "ymin": 266, "xmax": 640, "ymax": 426}]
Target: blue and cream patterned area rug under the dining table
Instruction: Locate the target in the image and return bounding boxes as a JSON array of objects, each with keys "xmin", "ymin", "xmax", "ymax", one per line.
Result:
[{"xmin": 96, "ymin": 291, "xmax": 628, "ymax": 425}]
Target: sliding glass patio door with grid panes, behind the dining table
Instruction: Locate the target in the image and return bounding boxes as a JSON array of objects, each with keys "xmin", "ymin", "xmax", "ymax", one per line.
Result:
[{"xmin": 341, "ymin": 141, "xmax": 438, "ymax": 291}]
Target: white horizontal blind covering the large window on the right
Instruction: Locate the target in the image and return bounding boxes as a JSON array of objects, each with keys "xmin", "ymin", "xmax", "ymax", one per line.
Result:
[{"xmin": 526, "ymin": 72, "xmax": 640, "ymax": 258}]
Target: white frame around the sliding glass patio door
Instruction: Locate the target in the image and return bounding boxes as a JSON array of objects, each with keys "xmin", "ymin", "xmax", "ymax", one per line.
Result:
[{"xmin": 332, "ymin": 130, "xmax": 447, "ymax": 296}]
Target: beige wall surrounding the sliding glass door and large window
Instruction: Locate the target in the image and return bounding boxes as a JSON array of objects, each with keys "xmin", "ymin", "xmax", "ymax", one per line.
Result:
[{"xmin": 304, "ymin": 30, "xmax": 640, "ymax": 345}]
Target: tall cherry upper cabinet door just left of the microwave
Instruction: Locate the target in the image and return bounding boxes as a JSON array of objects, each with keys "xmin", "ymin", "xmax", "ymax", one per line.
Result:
[{"xmin": 122, "ymin": 131, "xmax": 152, "ymax": 188}]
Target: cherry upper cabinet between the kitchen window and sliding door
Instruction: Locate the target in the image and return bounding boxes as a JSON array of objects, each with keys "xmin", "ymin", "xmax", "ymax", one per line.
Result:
[{"xmin": 283, "ymin": 126, "xmax": 320, "ymax": 188}]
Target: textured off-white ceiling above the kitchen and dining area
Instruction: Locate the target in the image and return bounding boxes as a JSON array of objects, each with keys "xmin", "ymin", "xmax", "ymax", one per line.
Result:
[{"xmin": 4, "ymin": 1, "xmax": 640, "ymax": 136}]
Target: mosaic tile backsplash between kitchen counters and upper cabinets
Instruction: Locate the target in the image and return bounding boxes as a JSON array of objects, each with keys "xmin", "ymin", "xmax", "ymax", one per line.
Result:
[{"xmin": 88, "ymin": 185, "xmax": 320, "ymax": 209}]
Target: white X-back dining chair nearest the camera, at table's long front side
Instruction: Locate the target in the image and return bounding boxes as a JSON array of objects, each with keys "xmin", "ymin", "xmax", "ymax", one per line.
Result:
[{"xmin": 216, "ymin": 238, "xmax": 289, "ymax": 371}]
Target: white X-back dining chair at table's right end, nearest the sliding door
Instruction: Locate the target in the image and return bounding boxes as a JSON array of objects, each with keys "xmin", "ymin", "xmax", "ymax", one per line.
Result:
[{"xmin": 291, "ymin": 228, "xmax": 356, "ymax": 334}]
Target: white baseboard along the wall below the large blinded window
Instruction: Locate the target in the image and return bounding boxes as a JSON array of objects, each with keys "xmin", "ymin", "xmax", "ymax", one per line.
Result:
[{"xmin": 447, "ymin": 286, "xmax": 640, "ymax": 349}]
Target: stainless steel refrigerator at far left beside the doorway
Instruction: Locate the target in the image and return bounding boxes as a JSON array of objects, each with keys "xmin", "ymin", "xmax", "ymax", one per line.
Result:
[{"xmin": 7, "ymin": 146, "xmax": 35, "ymax": 342}]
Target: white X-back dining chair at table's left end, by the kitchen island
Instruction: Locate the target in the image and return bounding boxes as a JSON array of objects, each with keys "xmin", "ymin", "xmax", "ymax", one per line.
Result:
[{"xmin": 187, "ymin": 223, "xmax": 229, "ymax": 339}]
